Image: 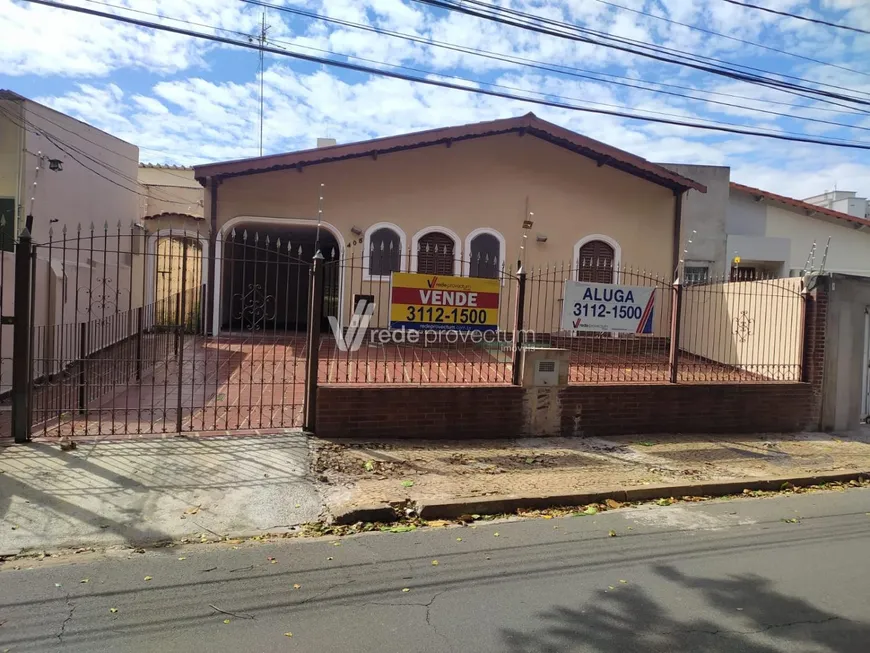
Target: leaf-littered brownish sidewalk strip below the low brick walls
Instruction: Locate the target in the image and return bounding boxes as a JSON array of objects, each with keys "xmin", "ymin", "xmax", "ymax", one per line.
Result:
[{"xmin": 314, "ymin": 430, "xmax": 870, "ymax": 514}]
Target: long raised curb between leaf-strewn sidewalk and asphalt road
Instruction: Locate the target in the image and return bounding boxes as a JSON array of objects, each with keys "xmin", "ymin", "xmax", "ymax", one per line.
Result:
[{"xmin": 414, "ymin": 471, "xmax": 870, "ymax": 519}]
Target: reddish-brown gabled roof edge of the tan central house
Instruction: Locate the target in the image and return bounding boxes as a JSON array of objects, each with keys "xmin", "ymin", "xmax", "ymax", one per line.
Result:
[{"xmin": 194, "ymin": 113, "xmax": 707, "ymax": 193}]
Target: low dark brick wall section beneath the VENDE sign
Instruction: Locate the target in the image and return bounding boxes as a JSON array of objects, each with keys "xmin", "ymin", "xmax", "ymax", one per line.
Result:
[{"xmin": 317, "ymin": 385, "xmax": 523, "ymax": 439}]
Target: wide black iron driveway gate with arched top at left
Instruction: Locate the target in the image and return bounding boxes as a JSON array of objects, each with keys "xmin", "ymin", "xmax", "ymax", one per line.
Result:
[{"xmin": 0, "ymin": 225, "xmax": 311, "ymax": 440}]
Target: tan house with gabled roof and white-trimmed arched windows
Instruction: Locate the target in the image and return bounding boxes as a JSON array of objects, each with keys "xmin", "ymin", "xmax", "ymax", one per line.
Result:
[{"xmin": 194, "ymin": 114, "xmax": 705, "ymax": 331}]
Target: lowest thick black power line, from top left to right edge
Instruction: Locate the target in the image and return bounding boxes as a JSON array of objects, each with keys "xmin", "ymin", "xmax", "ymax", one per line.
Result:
[{"xmin": 17, "ymin": 0, "xmax": 870, "ymax": 150}]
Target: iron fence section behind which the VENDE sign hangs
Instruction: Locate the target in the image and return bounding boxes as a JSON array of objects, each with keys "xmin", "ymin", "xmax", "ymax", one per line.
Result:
[{"xmin": 318, "ymin": 251, "xmax": 518, "ymax": 385}]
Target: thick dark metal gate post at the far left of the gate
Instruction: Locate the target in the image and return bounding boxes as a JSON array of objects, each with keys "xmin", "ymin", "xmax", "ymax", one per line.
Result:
[{"xmin": 12, "ymin": 228, "xmax": 34, "ymax": 443}]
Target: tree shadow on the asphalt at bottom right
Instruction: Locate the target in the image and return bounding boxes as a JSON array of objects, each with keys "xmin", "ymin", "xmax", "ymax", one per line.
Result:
[{"xmin": 501, "ymin": 565, "xmax": 870, "ymax": 653}]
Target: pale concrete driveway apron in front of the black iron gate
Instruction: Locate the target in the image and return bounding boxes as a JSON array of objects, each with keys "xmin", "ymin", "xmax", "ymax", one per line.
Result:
[{"xmin": 0, "ymin": 431, "xmax": 321, "ymax": 555}]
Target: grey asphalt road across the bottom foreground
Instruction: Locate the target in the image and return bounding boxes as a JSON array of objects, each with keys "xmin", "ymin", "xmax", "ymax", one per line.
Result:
[{"xmin": 0, "ymin": 490, "xmax": 870, "ymax": 653}]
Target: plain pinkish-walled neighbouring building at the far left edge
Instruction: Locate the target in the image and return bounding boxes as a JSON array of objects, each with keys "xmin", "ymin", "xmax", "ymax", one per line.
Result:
[{"xmin": 0, "ymin": 90, "xmax": 144, "ymax": 394}]
